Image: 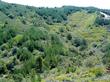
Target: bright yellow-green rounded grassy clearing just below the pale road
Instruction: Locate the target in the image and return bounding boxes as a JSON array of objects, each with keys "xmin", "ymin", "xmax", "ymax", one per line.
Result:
[{"xmin": 69, "ymin": 12, "xmax": 107, "ymax": 42}]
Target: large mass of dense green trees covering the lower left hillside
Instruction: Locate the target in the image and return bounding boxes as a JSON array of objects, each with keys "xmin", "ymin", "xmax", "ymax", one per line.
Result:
[{"xmin": 0, "ymin": 23, "xmax": 66, "ymax": 82}]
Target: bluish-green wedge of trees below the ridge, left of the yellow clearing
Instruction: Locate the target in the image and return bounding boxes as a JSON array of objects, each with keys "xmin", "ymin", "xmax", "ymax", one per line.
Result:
[{"xmin": 36, "ymin": 6, "xmax": 80, "ymax": 24}]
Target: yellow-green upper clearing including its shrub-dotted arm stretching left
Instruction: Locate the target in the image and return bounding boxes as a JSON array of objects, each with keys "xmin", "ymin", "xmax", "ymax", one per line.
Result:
[{"xmin": 46, "ymin": 11, "xmax": 108, "ymax": 53}]
